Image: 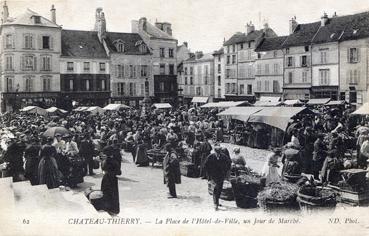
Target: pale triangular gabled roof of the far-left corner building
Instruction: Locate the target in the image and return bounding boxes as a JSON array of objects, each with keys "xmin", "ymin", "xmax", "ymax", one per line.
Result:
[{"xmin": 3, "ymin": 9, "xmax": 60, "ymax": 28}]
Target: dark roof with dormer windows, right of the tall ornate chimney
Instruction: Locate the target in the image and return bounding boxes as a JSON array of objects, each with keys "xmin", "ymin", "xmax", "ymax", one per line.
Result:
[{"xmin": 105, "ymin": 32, "xmax": 150, "ymax": 55}]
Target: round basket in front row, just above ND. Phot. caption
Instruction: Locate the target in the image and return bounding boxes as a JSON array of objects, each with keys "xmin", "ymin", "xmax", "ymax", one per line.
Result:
[{"xmin": 297, "ymin": 185, "xmax": 337, "ymax": 209}]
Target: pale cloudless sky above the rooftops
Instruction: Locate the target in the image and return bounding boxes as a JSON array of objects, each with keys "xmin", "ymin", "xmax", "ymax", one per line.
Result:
[{"xmin": 1, "ymin": 0, "xmax": 369, "ymax": 53}]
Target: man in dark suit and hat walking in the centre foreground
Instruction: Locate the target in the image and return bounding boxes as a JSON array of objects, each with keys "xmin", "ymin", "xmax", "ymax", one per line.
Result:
[{"xmin": 204, "ymin": 143, "xmax": 231, "ymax": 210}]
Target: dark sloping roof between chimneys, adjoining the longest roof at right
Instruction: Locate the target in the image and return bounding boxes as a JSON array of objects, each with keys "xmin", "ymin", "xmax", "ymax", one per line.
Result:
[{"xmin": 282, "ymin": 21, "xmax": 320, "ymax": 48}]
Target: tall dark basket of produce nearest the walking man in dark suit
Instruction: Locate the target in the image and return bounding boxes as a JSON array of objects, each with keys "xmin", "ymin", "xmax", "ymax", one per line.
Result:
[{"xmin": 231, "ymin": 171, "xmax": 262, "ymax": 208}]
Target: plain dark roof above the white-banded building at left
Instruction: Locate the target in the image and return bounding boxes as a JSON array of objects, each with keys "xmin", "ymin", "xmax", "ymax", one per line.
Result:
[{"xmin": 61, "ymin": 30, "xmax": 108, "ymax": 58}]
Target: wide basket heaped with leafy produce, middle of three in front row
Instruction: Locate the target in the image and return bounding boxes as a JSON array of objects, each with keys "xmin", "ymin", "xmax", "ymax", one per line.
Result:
[{"xmin": 257, "ymin": 182, "xmax": 299, "ymax": 210}]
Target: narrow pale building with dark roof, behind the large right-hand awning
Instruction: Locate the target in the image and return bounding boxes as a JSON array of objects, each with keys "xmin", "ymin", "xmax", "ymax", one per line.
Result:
[{"xmin": 255, "ymin": 36, "xmax": 287, "ymax": 99}]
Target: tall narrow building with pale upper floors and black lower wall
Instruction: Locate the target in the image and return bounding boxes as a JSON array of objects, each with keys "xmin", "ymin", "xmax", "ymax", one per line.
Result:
[{"xmin": 132, "ymin": 17, "xmax": 178, "ymax": 104}]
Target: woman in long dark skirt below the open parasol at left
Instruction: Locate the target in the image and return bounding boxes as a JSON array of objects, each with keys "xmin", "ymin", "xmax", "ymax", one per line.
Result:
[{"xmin": 38, "ymin": 137, "xmax": 60, "ymax": 189}]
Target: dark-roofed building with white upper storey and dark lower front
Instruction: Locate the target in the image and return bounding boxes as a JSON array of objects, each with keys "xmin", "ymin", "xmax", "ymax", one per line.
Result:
[{"xmin": 60, "ymin": 30, "xmax": 110, "ymax": 109}]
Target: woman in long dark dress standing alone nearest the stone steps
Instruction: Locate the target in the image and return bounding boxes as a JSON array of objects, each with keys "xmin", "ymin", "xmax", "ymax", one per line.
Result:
[{"xmin": 101, "ymin": 157, "xmax": 120, "ymax": 215}]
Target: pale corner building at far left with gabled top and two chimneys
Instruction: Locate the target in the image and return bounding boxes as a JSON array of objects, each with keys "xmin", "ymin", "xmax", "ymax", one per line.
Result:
[{"xmin": 0, "ymin": 3, "xmax": 61, "ymax": 111}]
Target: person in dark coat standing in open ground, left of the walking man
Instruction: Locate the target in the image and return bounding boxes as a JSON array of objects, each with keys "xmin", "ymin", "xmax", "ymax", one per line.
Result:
[{"xmin": 163, "ymin": 143, "xmax": 181, "ymax": 198}]
